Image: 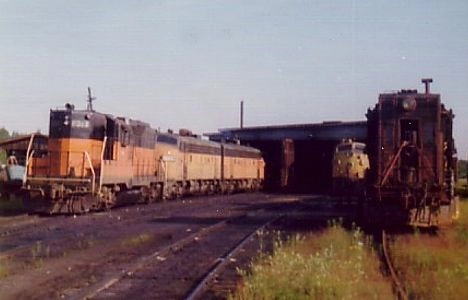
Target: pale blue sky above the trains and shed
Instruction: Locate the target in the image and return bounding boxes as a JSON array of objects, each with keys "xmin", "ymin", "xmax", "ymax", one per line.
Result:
[{"xmin": 0, "ymin": 0, "xmax": 468, "ymax": 158}]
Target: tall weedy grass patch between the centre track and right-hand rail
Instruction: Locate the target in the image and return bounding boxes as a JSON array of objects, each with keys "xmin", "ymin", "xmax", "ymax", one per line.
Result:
[{"xmin": 230, "ymin": 224, "xmax": 394, "ymax": 299}]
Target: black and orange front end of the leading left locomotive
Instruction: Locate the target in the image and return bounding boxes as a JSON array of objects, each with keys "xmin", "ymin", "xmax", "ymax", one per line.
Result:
[{"xmin": 23, "ymin": 104, "xmax": 106, "ymax": 213}]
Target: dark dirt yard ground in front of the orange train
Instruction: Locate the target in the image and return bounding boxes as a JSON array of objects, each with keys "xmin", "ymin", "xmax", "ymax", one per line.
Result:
[{"xmin": 0, "ymin": 193, "xmax": 352, "ymax": 299}]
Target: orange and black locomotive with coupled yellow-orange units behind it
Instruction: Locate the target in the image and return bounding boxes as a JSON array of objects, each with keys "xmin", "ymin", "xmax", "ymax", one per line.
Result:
[{"xmin": 23, "ymin": 91, "xmax": 265, "ymax": 213}]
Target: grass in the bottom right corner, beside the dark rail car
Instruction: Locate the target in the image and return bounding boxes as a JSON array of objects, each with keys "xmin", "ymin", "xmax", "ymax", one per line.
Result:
[{"xmin": 392, "ymin": 199, "xmax": 468, "ymax": 299}]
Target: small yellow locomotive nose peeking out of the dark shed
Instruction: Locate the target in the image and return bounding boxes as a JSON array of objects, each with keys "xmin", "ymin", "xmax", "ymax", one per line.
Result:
[{"xmin": 332, "ymin": 139, "xmax": 369, "ymax": 198}]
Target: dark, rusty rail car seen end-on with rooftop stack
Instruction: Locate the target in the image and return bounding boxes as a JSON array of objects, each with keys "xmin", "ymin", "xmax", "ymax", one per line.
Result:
[{"xmin": 365, "ymin": 79, "xmax": 457, "ymax": 226}]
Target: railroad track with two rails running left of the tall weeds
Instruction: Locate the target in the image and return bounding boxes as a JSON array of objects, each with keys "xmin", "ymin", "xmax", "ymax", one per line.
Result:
[{"xmin": 71, "ymin": 198, "xmax": 308, "ymax": 299}]
